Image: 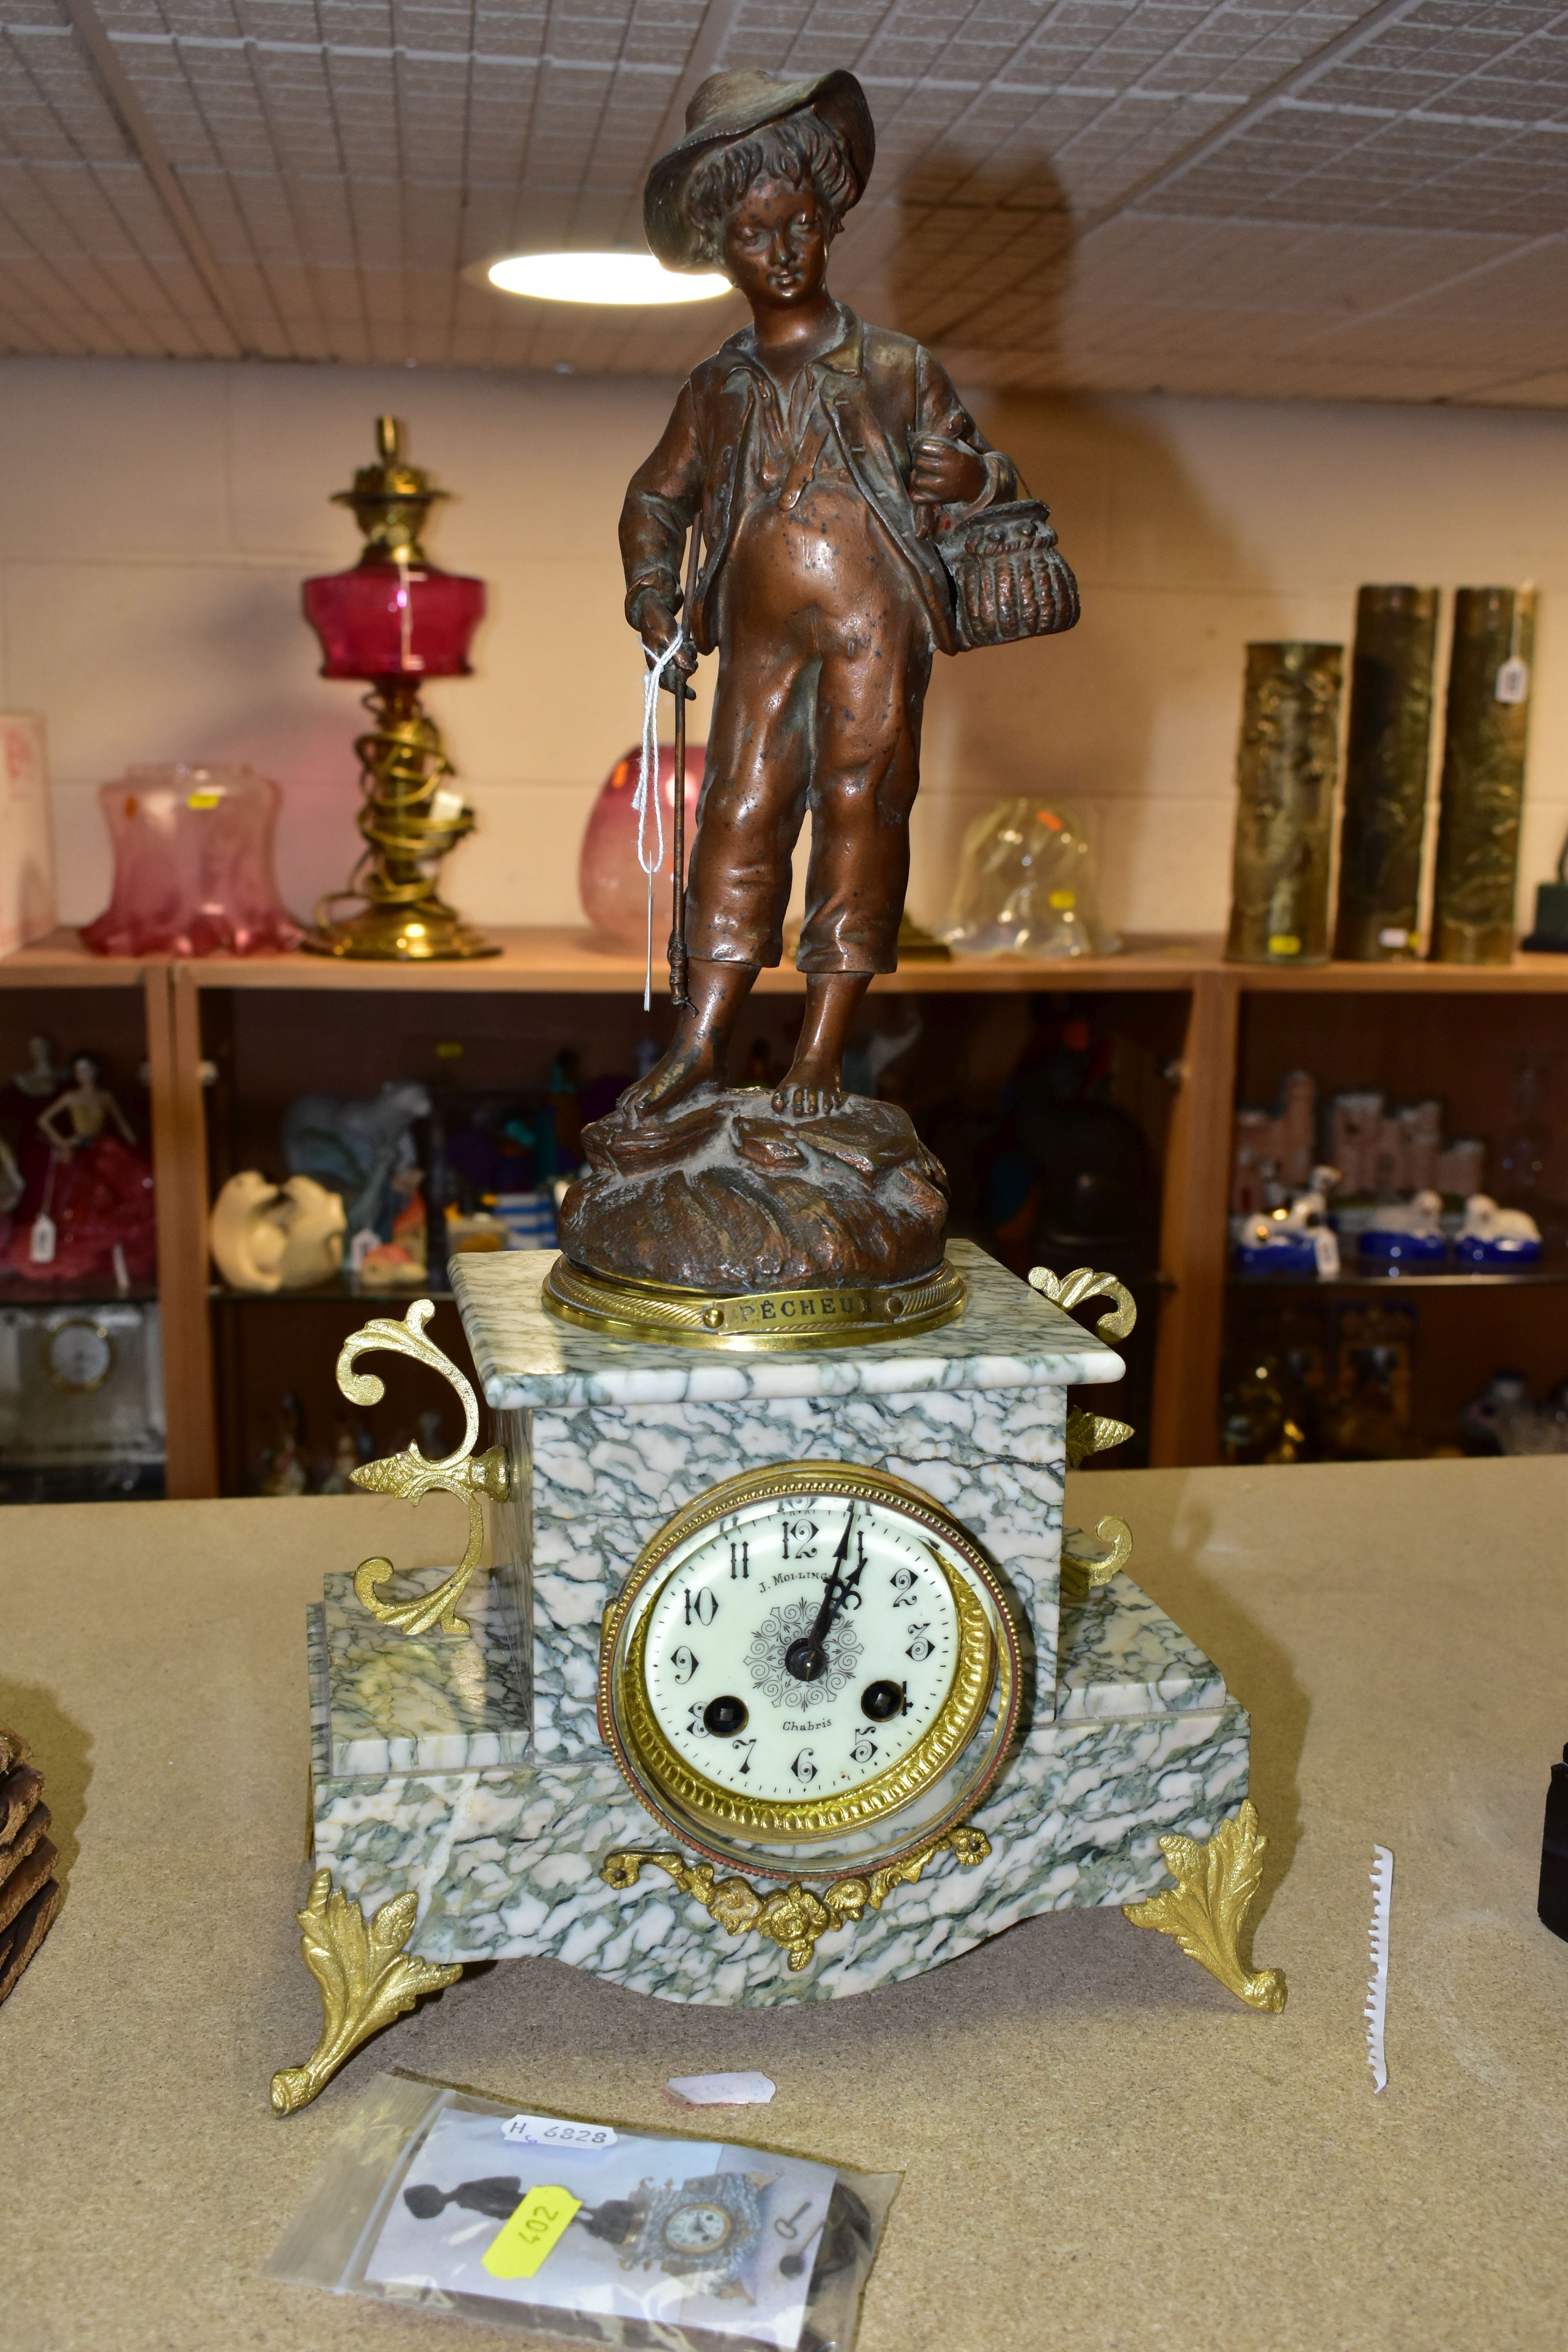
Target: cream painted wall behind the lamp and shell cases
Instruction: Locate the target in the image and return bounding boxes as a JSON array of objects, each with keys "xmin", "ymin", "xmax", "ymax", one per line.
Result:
[{"xmin": 0, "ymin": 360, "xmax": 1568, "ymax": 931}]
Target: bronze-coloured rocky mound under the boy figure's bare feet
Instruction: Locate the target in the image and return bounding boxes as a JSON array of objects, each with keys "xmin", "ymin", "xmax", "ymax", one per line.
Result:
[{"xmin": 559, "ymin": 1087, "xmax": 947, "ymax": 1294}]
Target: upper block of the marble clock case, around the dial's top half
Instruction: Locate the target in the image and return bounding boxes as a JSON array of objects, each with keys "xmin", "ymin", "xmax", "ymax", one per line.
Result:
[{"xmin": 454, "ymin": 1242, "xmax": 1122, "ymax": 1731}]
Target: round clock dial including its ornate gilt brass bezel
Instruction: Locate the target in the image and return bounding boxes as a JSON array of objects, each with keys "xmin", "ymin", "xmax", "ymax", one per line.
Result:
[{"xmin": 599, "ymin": 1463, "xmax": 1018, "ymax": 1870}]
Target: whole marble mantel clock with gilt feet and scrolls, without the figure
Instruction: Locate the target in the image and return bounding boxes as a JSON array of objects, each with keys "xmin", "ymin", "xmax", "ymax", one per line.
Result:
[{"xmin": 273, "ymin": 1242, "xmax": 1283, "ymax": 2112}]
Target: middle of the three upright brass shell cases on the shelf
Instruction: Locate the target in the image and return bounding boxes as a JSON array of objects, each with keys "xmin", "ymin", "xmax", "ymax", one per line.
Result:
[{"xmin": 1333, "ymin": 588, "xmax": 1439, "ymax": 964}]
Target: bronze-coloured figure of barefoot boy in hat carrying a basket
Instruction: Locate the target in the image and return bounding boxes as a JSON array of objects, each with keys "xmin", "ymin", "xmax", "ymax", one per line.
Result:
[{"xmin": 621, "ymin": 71, "xmax": 1034, "ymax": 1117}]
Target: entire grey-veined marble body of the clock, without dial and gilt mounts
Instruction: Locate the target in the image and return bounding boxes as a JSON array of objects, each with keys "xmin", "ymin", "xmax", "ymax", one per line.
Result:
[{"xmin": 297, "ymin": 1244, "xmax": 1248, "ymax": 2004}]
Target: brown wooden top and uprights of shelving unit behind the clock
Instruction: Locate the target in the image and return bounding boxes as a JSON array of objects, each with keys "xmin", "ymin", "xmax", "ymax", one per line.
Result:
[{"xmin": 0, "ymin": 929, "xmax": 1568, "ymax": 1496}]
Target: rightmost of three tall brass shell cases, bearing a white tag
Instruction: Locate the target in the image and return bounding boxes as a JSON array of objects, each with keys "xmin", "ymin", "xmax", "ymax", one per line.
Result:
[{"xmin": 1432, "ymin": 588, "xmax": 1535, "ymax": 964}]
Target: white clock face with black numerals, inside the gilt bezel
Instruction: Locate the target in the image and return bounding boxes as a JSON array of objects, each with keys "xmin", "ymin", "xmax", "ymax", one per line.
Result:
[{"xmin": 642, "ymin": 1494, "xmax": 959, "ymax": 1802}]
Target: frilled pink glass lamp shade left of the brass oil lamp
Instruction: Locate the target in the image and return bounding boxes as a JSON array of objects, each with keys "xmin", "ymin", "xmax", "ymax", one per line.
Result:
[{"xmin": 82, "ymin": 767, "xmax": 303, "ymax": 955}]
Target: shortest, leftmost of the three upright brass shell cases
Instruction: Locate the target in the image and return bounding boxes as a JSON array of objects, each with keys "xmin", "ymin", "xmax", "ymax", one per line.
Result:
[{"xmin": 1225, "ymin": 642, "xmax": 1345, "ymax": 964}]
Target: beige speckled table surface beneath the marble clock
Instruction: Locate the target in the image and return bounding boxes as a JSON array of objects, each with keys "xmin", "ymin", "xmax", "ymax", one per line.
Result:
[{"xmin": 0, "ymin": 1461, "xmax": 1568, "ymax": 2352}]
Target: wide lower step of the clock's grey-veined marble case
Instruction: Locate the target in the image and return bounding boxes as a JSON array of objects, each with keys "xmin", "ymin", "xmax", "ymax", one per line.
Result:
[{"xmin": 310, "ymin": 1576, "xmax": 1248, "ymax": 2004}]
